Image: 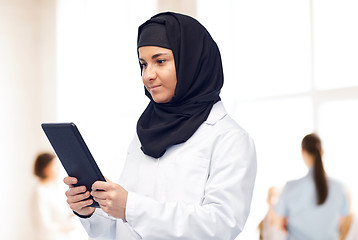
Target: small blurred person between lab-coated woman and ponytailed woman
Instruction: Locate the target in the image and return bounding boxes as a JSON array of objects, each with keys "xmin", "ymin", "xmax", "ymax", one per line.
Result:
[{"xmin": 258, "ymin": 187, "xmax": 287, "ymax": 240}]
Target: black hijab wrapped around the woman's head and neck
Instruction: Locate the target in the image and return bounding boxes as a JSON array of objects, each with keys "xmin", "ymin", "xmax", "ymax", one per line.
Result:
[{"xmin": 137, "ymin": 12, "xmax": 224, "ymax": 158}]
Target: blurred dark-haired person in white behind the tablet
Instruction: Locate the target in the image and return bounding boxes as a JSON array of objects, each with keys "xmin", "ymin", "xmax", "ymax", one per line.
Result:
[{"xmin": 31, "ymin": 153, "xmax": 75, "ymax": 240}]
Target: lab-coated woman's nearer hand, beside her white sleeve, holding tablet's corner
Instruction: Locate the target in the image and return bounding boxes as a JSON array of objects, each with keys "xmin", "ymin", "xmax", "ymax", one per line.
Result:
[{"xmin": 91, "ymin": 178, "xmax": 128, "ymax": 220}]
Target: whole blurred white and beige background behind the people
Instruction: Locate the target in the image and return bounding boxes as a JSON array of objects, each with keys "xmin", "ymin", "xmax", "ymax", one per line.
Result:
[{"xmin": 0, "ymin": 0, "xmax": 358, "ymax": 239}]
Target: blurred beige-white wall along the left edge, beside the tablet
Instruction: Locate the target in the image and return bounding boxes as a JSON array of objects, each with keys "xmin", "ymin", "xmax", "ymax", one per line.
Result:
[{"xmin": 0, "ymin": 0, "xmax": 56, "ymax": 239}]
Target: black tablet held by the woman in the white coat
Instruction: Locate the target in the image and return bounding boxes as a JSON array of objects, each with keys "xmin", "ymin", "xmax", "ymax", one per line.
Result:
[{"xmin": 41, "ymin": 123, "xmax": 106, "ymax": 208}]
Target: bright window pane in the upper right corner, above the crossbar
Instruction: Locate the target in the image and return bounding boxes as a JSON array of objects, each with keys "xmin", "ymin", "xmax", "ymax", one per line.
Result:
[{"xmin": 313, "ymin": 0, "xmax": 358, "ymax": 89}]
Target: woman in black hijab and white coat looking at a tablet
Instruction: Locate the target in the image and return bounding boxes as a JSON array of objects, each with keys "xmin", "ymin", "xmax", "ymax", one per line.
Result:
[{"xmin": 64, "ymin": 13, "xmax": 256, "ymax": 240}]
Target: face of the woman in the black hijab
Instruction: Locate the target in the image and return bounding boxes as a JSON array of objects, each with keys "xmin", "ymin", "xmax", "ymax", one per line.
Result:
[{"xmin": 138, "ymin": 46, "xmax": 177, "ymax": 103}]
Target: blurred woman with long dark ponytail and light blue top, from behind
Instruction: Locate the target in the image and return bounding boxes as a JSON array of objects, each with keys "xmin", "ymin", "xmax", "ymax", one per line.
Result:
[{"xmin": 275, "ymin": 134, "xmax": 348, "ymax": 240}]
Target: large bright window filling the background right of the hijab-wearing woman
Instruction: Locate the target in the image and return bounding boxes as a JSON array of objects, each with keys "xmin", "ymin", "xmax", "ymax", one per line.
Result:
[{"xmin": 198, "ymin": 0, "xmax": 358, "ymax": 239}]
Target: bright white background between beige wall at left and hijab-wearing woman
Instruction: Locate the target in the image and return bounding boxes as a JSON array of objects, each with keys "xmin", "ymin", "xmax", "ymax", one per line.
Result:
[{"xmin": 57, "ymin": 0, "xmax": 156, "ymax": 181}]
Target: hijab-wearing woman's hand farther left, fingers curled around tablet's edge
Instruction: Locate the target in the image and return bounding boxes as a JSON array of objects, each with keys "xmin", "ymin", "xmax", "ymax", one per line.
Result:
[{"xmin": 63, "ymin": 177, "xmax": 95, "ymax": 216}]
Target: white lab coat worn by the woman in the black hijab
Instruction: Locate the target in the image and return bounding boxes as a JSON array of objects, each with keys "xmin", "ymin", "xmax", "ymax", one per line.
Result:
[{"xmin": 81, "ymin": 102, "xmax": 256, "ymax": 240}]
